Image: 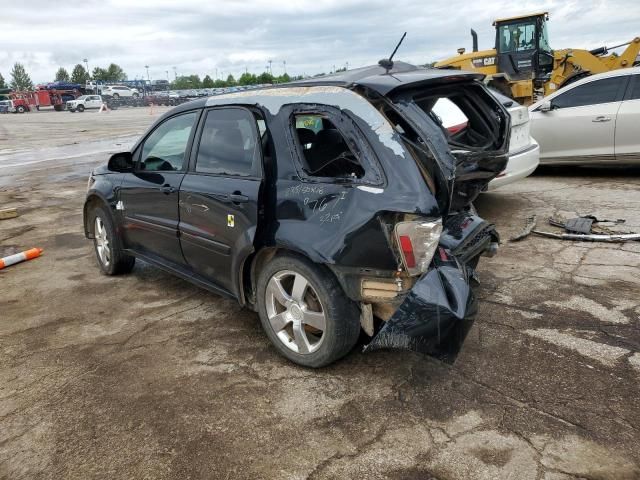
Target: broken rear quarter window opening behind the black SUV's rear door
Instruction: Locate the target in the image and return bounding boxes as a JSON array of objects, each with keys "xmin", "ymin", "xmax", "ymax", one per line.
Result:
[{"xmin": 293, "ymin": 114, "xmax": 365, "ymax": 178}]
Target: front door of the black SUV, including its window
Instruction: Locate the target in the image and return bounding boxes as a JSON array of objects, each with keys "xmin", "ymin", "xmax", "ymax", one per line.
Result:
[{"xmin": 118, "ymin": 110, "xmax": 200, "ymax": 266}]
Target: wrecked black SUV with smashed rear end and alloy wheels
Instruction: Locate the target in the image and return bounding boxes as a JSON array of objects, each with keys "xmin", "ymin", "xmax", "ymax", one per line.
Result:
[{"xmin": 84, "ymin": 62, "xmax": 510, "ymax": 367}]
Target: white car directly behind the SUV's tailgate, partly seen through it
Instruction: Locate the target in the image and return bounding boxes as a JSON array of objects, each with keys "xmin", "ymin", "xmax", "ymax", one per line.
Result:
[{"xmin": 433, "ymin": 90, "xmax": 540, "ymax": 190}]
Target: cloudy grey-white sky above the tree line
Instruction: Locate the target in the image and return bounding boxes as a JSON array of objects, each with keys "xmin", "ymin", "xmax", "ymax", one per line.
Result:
[{"xmin": 0, "ymin": 0, "xmax": 640, "ymax": 83}]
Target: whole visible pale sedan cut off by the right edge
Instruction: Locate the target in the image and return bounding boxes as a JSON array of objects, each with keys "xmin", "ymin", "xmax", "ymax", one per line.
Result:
[{"xmin": 529, "ymin": 68, "xmax": 640, "ymax": 165}]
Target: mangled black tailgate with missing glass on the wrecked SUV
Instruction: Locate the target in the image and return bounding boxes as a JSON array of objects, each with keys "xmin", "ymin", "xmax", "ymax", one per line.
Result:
[{"xmin": 385, "ymin": 75, "xmax": 511, "ymax": 214}]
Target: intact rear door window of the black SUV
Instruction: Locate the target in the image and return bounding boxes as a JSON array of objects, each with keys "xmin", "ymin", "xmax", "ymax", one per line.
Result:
[{"xmin": 196, "ymin": 108, "xmax": 261, "ymax": 177}]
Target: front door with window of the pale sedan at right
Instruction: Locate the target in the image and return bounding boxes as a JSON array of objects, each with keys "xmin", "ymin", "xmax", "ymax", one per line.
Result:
[{"xmin": 531, "ymin": 75, "xmax": 628, "ymax": 163}]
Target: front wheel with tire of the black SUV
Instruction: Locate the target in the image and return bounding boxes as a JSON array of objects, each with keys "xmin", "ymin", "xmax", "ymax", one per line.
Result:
[{"xmin": 90, "ymin": 207, "xmax": 136, "ymax": 275}]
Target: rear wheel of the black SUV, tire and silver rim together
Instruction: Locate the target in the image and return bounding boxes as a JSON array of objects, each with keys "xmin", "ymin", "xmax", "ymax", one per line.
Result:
[{"xmin": 257, "ymin": 255, "xmax": 360, "ymax": 368}]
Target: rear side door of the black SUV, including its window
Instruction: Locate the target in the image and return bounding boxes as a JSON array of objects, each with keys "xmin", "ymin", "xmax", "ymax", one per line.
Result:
[{"xmin": 179, "ymin": 107, "xmax": 263, "ymax": 297}]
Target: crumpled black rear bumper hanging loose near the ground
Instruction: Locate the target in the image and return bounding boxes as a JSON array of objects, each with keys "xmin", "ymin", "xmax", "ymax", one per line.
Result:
[{"xmin": 365, "ymin": 253, "xmax": 477, "ymax": 363}]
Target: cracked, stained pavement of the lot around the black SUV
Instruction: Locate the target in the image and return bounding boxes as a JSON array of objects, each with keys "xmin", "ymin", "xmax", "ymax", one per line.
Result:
[{"xmin": 0, "ymin": 108, "xmax": 640, "ymax": 480}]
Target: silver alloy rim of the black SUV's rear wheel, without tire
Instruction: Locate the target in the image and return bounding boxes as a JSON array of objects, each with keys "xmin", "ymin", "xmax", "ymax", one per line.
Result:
[{"xmin": 265, "ymin": 270, "xmax": 327, "ymax": 355}]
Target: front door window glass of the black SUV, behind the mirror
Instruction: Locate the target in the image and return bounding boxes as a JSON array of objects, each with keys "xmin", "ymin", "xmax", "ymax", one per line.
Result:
[{"xmin": 139, "ymin": 112, "xmax": 197, "ymax": 172}]
